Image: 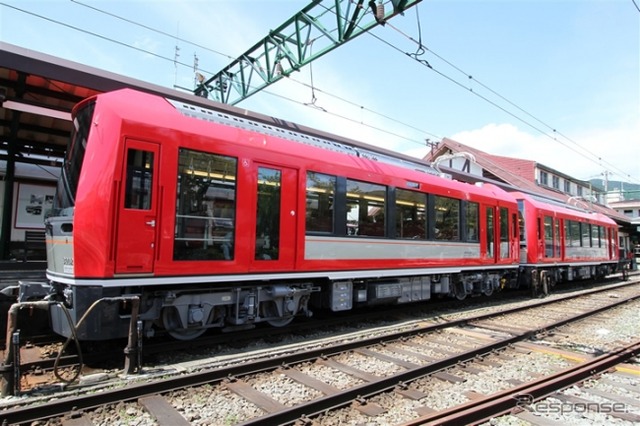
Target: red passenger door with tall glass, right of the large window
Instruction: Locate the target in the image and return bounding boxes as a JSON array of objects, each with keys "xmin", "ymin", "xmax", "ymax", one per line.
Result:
[{"xmin": 252, "ymin": 164, "xmax": 298, "ymax": 270}]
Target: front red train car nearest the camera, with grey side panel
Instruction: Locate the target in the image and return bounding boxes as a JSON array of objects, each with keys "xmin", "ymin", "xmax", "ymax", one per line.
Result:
[{"xmin": 46, "ymin": 89, "xmax": 519, "ymax": 340}]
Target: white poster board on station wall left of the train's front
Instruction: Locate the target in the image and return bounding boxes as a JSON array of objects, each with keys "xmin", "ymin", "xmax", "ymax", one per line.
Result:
[{"xmin": 14, "ymin": 183, "xmax": 56, "ymax": 229}]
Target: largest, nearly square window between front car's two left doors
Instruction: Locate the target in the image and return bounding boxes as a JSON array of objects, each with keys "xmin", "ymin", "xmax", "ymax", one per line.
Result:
[{"xmin": 173, "ymin": 149, "xmax": 237, "ymax": 260}]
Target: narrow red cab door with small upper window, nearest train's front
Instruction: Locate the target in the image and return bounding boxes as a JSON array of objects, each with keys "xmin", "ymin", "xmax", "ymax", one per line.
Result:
[{"xmin": 115, "ymin": 139, "xmax": 160, "ymax": 274}]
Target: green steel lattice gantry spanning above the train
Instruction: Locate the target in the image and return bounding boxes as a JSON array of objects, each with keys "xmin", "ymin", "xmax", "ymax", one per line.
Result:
[{"xmin": 194, "ymin": 0, "xmax": 421, "ymax": 105}]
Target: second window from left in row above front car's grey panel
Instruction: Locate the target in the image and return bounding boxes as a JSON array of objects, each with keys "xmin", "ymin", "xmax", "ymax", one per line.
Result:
[{"xmin": 346, "ymin": 179, "xmax": 387, "ymax": 237}]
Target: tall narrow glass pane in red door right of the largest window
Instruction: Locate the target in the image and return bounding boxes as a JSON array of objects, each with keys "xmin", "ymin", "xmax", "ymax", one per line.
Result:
[{"xmin": 255, "ymin": 167, "xmax": 282, "ymax": 260}]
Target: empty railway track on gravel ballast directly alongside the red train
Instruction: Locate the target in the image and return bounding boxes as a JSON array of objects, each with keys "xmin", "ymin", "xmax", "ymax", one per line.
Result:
[{"xmin": 0, "ymin": 285, "xmax": 640, "ymax": 424}]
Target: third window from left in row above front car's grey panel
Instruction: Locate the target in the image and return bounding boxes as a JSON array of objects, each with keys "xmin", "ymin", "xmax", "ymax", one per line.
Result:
[{"xmin": 396, "ymin": 189, "xmax": 427, "ymax": 240}]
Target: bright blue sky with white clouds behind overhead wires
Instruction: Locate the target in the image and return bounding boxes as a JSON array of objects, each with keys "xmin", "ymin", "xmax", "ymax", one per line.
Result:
[{"xmin": 0, "ymin": 0, "xmax": 640, "ymax": 183}]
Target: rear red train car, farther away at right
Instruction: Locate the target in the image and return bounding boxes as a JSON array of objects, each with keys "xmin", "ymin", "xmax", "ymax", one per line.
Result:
[{"xmin": 513, "ymin": 193, "xmax": 619, "ymax": 293}]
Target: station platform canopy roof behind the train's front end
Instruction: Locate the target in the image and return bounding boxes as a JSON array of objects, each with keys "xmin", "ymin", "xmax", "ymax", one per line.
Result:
[{"xmin": 0, "ymin": 42, "xmax": 249, "ymax": 179}]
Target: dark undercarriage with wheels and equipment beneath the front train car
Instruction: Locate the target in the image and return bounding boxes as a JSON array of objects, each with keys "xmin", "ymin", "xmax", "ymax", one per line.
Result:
[{"xmin": 48, "ymin": 269, "xmax": 517, "ymax": 340}]
